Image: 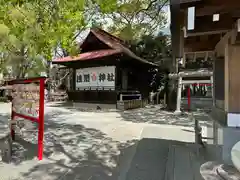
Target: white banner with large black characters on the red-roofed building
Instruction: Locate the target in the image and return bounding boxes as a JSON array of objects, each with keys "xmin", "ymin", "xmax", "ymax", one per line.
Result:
[{"xmin": 76, "ymin": 66, "xmax": 115, "ymax": 90}]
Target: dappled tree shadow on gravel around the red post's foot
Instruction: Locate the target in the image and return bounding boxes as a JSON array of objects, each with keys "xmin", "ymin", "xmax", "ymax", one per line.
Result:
[{"xmin": 6, "ymin": 108, "xmax": 137, "ymax": 180}]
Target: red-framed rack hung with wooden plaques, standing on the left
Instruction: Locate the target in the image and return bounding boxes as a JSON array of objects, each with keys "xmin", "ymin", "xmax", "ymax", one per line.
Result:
[{"xmin": 9, "ymin": 77, "xmax": 46, "ymax": 160}]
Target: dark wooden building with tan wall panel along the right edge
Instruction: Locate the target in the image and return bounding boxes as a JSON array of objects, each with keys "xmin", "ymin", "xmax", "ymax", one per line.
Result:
[{"xmin": 170, "ymin": 0, "xmax": 240, "ymax": 163}]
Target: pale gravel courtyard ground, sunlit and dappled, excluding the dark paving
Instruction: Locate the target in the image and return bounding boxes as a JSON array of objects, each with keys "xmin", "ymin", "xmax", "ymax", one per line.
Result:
[{"xmin": 0, "ymin": 104, "xmax": 212, "ymax": 180}]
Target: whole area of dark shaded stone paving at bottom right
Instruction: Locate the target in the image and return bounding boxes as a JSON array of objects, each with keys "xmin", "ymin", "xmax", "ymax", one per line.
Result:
[{"xmin": 126, "ymin": 138, "xmax": 218, "ymax": 180}]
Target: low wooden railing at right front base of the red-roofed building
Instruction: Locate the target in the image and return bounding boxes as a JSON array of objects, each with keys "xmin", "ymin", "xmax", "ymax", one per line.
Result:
[{"xmin": 117, "ymin": 99, "xmax": 148, "ymax": 110}]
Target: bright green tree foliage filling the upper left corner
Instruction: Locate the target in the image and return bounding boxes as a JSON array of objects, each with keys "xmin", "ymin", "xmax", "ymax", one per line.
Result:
[{"xmin": 0, "ymin": 0, "xmax": 116, "ymax": 77}]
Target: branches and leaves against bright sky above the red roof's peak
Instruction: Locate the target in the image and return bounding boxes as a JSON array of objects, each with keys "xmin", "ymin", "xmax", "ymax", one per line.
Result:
[{"xmin": 103, "ymin": 0, "xmax": 168, "ymax": 41}]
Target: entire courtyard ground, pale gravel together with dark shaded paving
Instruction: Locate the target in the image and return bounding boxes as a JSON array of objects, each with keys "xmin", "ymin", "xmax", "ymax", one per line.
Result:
[{"xmin": 0, "ymin": 104, "xmax": 219, "ymax": 180}]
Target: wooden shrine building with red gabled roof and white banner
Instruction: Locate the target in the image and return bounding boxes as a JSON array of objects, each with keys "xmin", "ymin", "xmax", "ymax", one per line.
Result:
[{"xmin": 53, "ymin": 28, "xmax": 157, "ymax": 104}]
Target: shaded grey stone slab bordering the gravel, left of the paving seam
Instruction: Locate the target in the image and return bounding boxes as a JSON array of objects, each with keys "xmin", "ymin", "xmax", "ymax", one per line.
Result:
[{"xmin": 126, "ymin": 138, "xmax": 170, "ymax": 180}]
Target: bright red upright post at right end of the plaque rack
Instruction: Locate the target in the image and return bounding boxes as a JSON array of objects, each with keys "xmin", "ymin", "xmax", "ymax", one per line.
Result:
[{"xmin": 38, "ymin": 78, "xmax": 45, "ymax": 160}]
